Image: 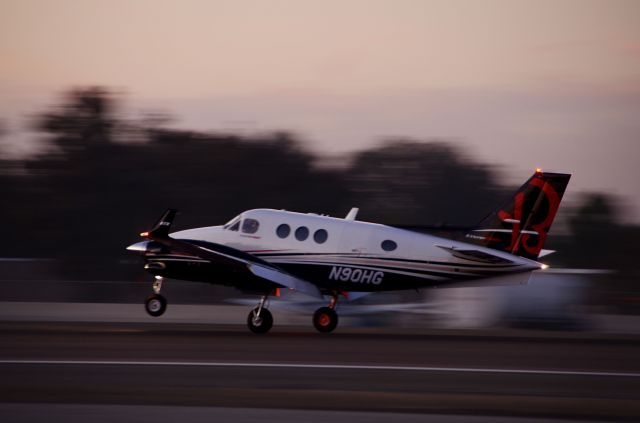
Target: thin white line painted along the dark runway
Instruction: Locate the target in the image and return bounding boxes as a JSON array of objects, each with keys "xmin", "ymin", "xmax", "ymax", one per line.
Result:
[{"xmin": 0, "ymin": 360, "xmax": 640, "ymax": 378}]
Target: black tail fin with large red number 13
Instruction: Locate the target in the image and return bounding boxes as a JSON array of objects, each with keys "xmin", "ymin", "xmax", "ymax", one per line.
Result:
[{"xmin": 466, "ymin": 171, "xmax": 571, "ymax": 260}]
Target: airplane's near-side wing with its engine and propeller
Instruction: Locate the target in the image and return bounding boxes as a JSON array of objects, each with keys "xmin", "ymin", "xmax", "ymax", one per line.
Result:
[{"xmin": 140, "ymin": 209, "xmax": 322, "ymax": 298}]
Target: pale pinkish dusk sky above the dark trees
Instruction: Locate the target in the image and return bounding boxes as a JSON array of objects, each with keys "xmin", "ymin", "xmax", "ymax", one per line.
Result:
[{"xmin": 0, "ymin": 0, "xmax": 640, "ymax": 222}]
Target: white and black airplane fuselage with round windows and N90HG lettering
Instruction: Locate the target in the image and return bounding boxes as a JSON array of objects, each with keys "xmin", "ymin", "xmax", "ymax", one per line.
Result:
[{"xmin": 171, "ymin": 209, "xmax": 541, "ymax": 291}]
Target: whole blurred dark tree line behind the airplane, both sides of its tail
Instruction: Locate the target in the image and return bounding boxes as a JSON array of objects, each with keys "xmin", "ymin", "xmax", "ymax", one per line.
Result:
[{"xmin": 0, "ymin": 87, "xmax": 640, "ymax": 304}]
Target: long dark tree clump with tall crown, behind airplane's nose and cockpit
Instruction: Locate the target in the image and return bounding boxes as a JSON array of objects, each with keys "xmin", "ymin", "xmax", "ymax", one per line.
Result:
[{"xmin": 0, "ymin": 88, "xmax": 347, "ymax": 277}]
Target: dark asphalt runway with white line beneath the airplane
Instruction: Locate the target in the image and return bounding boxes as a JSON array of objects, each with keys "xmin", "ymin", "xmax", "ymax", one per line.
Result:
[{"xmin": 0, "ymin": 322, "xmax": 640, "ymax": 422}]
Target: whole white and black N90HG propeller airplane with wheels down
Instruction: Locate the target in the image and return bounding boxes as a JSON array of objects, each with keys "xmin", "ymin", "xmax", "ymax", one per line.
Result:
[{"xmin": 127, "ymin": 169, "xmax": 571, "ymax": 334}]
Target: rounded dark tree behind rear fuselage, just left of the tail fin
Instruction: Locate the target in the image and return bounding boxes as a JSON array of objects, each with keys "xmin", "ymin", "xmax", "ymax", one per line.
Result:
[{"xmin": 348, "ymin": 140, "xmax": 502, "ymax": 225}]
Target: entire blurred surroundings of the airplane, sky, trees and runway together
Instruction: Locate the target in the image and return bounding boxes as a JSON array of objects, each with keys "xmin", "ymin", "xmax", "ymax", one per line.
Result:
[{"xmin": 0, "ymin": 4, "xmax": 640, "ymax": 423}]
